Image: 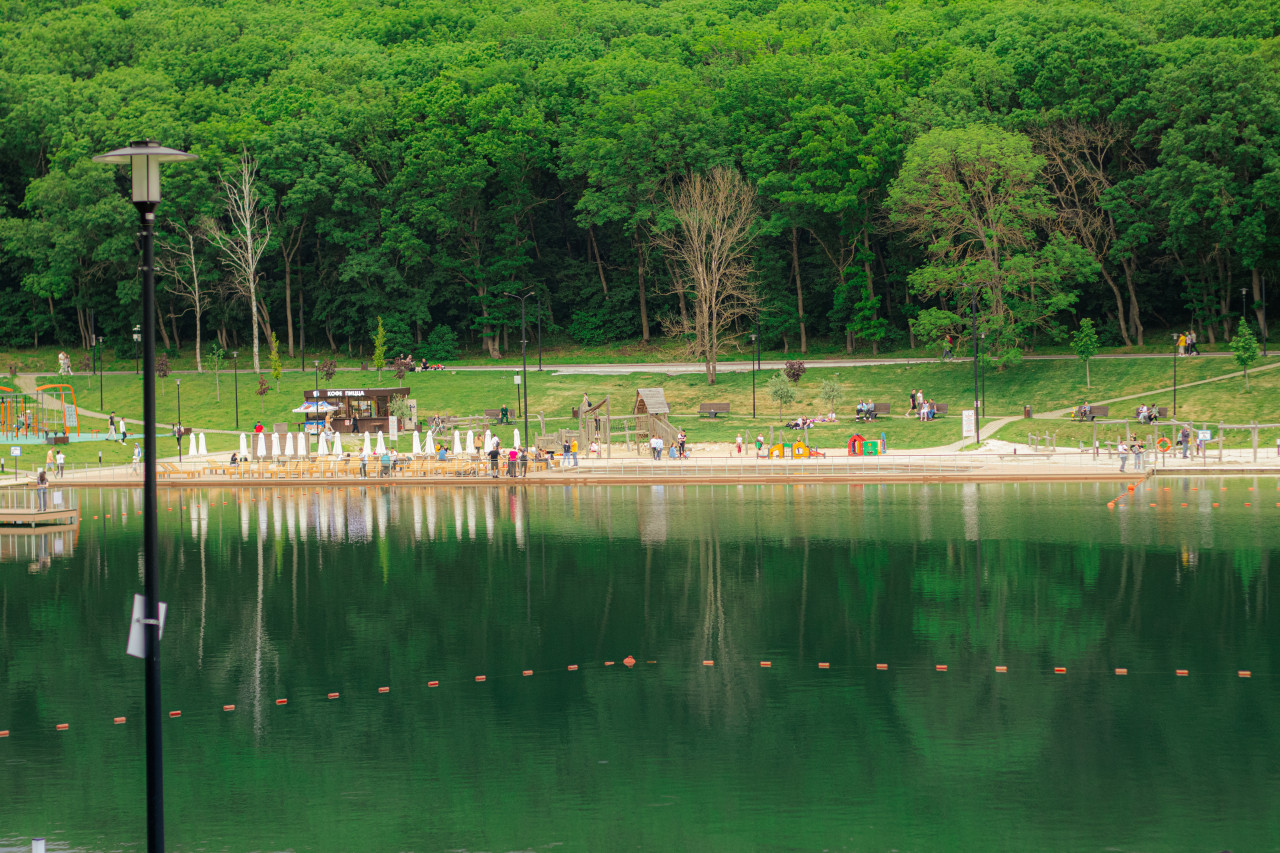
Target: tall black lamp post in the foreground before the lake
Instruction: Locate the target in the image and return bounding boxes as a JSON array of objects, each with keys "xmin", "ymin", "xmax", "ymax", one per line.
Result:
[{"xmin": 93, "ymin": 140, "xmax": 196, "ymax": 853}]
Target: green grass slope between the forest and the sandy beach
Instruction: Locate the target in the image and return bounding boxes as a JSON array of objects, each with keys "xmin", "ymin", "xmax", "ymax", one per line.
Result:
[{"xmin": 41, "ymin": 350, "xmax": 1280, "ymax": 450}]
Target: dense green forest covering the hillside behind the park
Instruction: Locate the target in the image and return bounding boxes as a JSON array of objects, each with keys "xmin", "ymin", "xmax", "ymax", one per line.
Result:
[{"xmin": 0, "ymin": 0, "xmax": 1280, "ymax": 365}]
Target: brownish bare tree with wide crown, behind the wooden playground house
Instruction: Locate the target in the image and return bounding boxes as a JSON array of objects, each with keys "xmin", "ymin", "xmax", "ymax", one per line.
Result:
[{"xmin": 655, "ymin": 168, "xmax": 760, "ymax": 386}]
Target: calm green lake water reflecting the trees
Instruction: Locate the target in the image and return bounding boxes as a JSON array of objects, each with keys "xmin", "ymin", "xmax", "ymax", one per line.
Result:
[{"xmin": 0, "ymin": 479, "xmax": 1280, "ymax": 852}]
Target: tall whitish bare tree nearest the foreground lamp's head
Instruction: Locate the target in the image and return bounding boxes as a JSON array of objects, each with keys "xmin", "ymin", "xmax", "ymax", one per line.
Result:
[{"xmin": 209, "ymin": 149, "xmax": 271, "ymax": 373}]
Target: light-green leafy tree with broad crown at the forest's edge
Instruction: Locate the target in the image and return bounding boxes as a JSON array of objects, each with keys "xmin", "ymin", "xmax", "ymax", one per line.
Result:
[{"xmin": 890, "ymin": 124, "xmax": 1097, "ymax": 364}]
